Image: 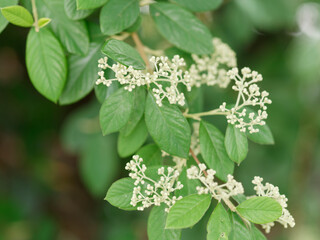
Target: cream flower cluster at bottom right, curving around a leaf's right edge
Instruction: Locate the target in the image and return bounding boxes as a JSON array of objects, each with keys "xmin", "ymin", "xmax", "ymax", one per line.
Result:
[{"xmin": 252, "ymin": 177, "xmax": 295, "ymax": 233}]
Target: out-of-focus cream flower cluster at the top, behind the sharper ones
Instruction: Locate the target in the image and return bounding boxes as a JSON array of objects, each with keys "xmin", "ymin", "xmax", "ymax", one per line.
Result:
[{"xmin": 189, "ymin": 38, "xmax": 237, "ymax": 88}]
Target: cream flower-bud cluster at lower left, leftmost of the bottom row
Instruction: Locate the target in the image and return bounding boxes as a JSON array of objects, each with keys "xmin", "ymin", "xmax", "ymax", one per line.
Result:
[{"xmin": 125, "ymin": 155, "xmax": 183, "ymax": 212}]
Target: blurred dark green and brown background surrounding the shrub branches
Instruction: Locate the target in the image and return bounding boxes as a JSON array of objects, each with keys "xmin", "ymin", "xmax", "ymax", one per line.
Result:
[{"xmin": 0, "ymin": 0, "xmax": 320, "ymax": 240}]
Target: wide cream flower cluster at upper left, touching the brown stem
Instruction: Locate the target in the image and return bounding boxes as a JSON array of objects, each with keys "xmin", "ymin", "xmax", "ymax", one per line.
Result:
[{"xmin": 96, "ymin": 55, "xmax": 191, "ymax": 106}]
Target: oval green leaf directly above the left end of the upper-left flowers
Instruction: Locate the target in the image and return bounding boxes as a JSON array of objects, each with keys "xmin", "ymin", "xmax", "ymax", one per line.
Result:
[{"xmin": 102, "ymin": 39, "xmax": 146, "ymax": 70}]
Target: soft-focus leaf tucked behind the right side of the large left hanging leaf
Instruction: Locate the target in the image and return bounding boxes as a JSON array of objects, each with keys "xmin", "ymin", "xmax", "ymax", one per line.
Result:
[{"xmin": 59, "ymin": 41, "xmax": 105, "ymax": 105}]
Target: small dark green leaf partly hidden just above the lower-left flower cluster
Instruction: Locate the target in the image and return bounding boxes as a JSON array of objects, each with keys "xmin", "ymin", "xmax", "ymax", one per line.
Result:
[{"xmin": 137, "ymin": 144, "xmax": 163, "ymax": 167}]
